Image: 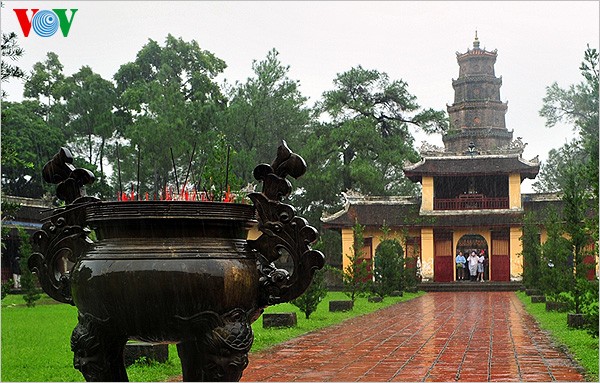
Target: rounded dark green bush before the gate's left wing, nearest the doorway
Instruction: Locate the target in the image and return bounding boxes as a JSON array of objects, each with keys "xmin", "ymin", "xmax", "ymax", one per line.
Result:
[{"xmin": 372, "ymin": 225, "xmax": 405, "ymax": 298}]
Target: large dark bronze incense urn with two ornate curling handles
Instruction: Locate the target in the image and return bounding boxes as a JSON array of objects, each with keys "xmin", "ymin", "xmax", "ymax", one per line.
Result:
[{"xmin": 29, "ymin": 142, "xmax": 324, "ymax": 381}]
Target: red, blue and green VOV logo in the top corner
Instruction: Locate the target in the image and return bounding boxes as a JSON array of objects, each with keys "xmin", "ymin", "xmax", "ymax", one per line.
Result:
[{"xmin": 13, "ymin": 9, "xmax": 77, "ymax": 37}]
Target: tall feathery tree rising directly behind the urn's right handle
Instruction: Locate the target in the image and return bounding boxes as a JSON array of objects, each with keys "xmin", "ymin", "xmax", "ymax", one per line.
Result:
[{"xmin": 224, "ymin": 49, "xmax": 310, "ymax": 182}]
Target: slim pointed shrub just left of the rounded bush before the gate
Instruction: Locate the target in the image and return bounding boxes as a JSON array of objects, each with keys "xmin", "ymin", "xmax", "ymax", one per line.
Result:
[{"xmin": 342, "ymin": 222, "xmax": 370, "ymax": 302}]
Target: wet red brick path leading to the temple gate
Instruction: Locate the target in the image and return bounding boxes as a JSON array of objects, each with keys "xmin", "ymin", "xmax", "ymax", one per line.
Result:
[{"xmin": 242, "ymin": 292, "xmax": 585, "ymax": 382}]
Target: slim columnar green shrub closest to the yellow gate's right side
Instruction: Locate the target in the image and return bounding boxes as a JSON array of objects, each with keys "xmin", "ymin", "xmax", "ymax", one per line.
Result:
[{"xmin": 521, "ymin": 213, "xmax": 542, "ymax": 289}]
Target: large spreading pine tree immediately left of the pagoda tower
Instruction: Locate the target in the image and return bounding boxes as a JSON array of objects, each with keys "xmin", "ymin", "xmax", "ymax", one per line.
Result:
[{"xmin": 300, "ymin": 66, "xmax": 447, "ymax": 224}]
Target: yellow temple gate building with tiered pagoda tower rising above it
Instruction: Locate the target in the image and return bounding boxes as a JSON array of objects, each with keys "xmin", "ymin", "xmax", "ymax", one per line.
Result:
[{"xmin": 322, "ymin": 36, "xmax": 580, "ymax": 282}]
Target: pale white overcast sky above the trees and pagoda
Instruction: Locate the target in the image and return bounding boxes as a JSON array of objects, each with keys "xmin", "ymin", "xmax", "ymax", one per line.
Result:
[{"xmin": 0, "ymin": 1, "xmax": 600, "ymax": 191}]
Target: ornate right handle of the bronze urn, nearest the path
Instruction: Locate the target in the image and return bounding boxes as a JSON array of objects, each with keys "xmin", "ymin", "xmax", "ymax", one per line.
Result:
[{"xmin": 248, "ymin": 141, "xmax": 325, "ymax": 306}]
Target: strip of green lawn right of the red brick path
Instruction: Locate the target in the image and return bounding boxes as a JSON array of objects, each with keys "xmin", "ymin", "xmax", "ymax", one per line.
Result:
[{"xmin": 517, "ymin": 292, "xmax": 599, "ymax": 382}]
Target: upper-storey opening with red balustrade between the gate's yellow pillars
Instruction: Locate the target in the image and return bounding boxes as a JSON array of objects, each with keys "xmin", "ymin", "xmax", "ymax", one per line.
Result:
[{"xmin": 433, "ymin": 175, "xmax": 508, "ymax": 210}]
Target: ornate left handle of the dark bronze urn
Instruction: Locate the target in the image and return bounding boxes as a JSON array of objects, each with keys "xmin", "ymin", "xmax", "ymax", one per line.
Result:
[{"xmin": 28, "ymin": 148, "xmax": 99, "ymax": 304}]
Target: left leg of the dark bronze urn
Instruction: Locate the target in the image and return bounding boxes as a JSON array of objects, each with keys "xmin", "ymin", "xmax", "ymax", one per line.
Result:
[{"xmin": 71, "ymin": 314, "xmax": 129, "ymax": 382}]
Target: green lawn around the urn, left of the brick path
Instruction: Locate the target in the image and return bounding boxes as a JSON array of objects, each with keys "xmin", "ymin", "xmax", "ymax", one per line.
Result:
[{"xmin": 0, "ymin": 292, "xmax": 423, "ymax": 382}]
